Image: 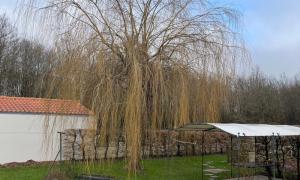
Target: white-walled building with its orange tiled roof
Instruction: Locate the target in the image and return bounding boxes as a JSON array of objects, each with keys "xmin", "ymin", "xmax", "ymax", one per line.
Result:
[{"xmin": 0, "ymin": 96, "xmax": 91, "ymax": 164}]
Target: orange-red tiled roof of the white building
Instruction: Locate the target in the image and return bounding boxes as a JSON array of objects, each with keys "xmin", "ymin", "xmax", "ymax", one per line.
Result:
[{"xmin": 0, "ymin": 96, "xmax": 90, "ymax": 115}]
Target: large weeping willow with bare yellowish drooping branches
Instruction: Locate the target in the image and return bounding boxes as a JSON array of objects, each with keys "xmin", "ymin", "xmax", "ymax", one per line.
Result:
[{"xmin": 19, "ymin": 0, "xmax": 243, "ymax": 172}]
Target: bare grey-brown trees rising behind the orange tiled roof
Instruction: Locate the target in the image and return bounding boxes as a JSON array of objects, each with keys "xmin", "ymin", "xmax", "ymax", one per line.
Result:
[{"xmin": 0, "ymin": 15, "xmax": 53, "ymax": 97}]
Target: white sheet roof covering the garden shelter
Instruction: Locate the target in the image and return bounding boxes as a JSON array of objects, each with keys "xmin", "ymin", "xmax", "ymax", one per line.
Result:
[{"xmin": 208, "ymin": 123, "xmax": 300, "ymax": 136}]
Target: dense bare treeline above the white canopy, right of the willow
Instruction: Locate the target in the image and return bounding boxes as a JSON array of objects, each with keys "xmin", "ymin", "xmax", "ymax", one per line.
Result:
[{"xmin": 222, "ymin": 71, "xmax": 300, "ymax": 124}]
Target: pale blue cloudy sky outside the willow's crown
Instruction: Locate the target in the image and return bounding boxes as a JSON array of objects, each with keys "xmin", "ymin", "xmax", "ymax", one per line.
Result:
[{"xmin": 0, "ymin": 0, "xmax": 300, "ymax": 77}]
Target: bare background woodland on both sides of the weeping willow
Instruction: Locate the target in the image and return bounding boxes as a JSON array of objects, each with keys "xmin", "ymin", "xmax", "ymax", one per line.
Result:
[{"xmin": 0, "ymin": 15, "xmax": 300, "ymax": 124}]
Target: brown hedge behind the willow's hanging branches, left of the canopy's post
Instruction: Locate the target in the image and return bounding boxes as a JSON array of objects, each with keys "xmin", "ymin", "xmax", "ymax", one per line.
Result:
[{"xmin": 63, "ymin": 129, "xmax": 228, "ymax": 160}]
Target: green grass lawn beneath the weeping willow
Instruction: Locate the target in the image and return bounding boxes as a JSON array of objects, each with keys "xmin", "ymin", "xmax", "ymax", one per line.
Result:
[{"xmin": 0, "ymin": 155, "xmax": 258, "ymax": 180}]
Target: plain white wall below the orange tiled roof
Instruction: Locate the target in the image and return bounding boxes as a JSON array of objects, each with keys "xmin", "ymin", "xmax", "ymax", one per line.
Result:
[{"xmin": 0, "ymin": 113, "xmax": 88, "ymax": 164}]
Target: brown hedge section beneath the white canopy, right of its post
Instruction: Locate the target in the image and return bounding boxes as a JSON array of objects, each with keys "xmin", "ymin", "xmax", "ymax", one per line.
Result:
[{"xmin": 228, "ymin": 137, "xmax": 296, "ymax": 166}]
